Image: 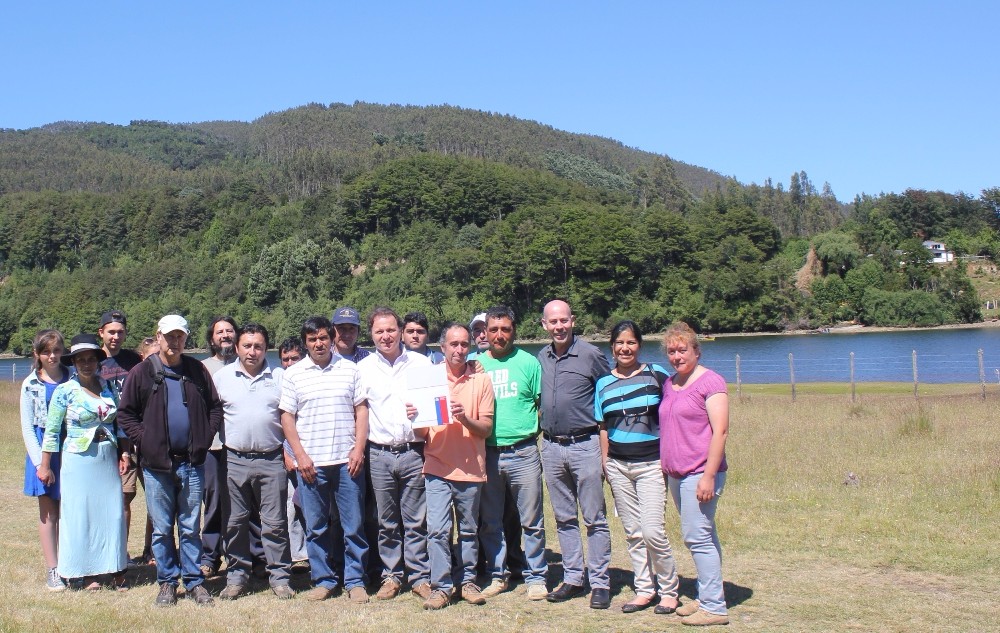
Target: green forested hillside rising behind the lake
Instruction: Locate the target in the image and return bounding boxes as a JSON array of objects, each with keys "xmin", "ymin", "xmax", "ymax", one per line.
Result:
[{"xmin": 0, "ymin": 103, "xmax": 1000, "ymax": 352}]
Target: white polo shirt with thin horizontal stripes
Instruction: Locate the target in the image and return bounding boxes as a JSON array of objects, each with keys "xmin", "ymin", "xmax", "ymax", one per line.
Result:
[{"xmin": 278, "ymin": 354, "xmax": 365, "ymax": 466}]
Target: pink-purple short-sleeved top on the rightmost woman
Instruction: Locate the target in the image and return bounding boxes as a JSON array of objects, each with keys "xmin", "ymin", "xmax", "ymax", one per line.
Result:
[{"xmin": 660, "ymin": 369, "xmax": 728, "ymax": 477}]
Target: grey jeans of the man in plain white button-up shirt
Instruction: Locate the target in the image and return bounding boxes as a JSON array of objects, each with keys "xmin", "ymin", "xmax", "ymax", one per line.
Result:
[{"xmin": 368, "ymin": 445, "xmax": 430, "ymax": 587}]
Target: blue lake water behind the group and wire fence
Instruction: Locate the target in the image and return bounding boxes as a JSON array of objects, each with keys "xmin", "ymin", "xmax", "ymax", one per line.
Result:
[{"xmin": 7, "ymin": 328, "xmax": 1000, "ymax": 384}]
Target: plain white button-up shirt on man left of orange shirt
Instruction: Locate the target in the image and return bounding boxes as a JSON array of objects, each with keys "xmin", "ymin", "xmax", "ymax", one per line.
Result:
[{"xmin": 358, "ymin": 349, "xmax": 431, "ymax": 444}]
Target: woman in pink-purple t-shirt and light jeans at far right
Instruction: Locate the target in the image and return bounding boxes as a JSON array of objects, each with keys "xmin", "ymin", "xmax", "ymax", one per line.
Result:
[{"xmin": 660, "ymin": 322, "xmax": 729, "ymax": 625}]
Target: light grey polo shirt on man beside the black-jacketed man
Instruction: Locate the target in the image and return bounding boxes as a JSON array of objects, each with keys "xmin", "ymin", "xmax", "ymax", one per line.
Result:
[{"xmin": 212, "ymin": 361, "xmax": 285, "ymax": 453}]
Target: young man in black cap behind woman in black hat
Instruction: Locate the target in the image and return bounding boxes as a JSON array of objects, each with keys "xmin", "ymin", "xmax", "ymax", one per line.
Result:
[{"xmin": 97, "ymin": 310, "xmax": 142, "ymax": 560}]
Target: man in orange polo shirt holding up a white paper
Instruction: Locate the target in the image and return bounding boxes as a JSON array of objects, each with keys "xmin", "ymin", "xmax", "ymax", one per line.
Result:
[{"xmin": 415, "ymin": 323, "xmax": 493, "ymax": 609}]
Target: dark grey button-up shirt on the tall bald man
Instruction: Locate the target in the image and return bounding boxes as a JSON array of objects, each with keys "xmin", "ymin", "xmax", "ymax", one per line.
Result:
[{"xmin": 538, "ymin": 336, "xmax": 611, "ymax": 435}]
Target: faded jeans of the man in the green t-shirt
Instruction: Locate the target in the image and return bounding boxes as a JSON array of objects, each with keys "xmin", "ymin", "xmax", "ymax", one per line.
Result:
[{"xmin": 479, "ymin": 444, "xmax": 549, "ymax": 585}]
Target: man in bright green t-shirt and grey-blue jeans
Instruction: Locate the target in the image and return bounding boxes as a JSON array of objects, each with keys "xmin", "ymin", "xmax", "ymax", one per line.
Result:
[{"xmin": 477, "ymin": 306, "xmax": 548, "ymax": 600}]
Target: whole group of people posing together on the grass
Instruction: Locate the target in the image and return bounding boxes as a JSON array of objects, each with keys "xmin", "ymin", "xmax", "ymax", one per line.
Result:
[{"xmin": 21, "ymin": 300, "xmax": 729, "ymax": 625}]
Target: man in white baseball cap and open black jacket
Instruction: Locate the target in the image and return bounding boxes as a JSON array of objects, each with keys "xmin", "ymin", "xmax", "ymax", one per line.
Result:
[{"xmin": 118, "ymin": 314, "xmax": 223, "ymax": 607}]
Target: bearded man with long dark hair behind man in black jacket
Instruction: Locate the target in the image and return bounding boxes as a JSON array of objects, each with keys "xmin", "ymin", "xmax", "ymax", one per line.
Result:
[{"xmin": 201, "ymin": 316, "xmax": 237, "ymax": 577}]
